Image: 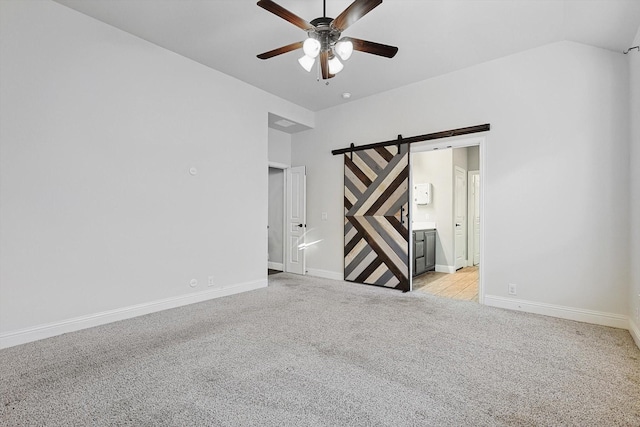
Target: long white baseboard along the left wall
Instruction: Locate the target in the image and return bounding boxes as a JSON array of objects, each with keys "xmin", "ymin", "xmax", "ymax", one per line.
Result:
[{"xmin": 0, "ymin": 279, "xmax": 267, "ymax": 348}]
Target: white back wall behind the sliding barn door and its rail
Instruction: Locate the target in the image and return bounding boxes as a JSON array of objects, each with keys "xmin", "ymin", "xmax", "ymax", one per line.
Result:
[{"xmin": 292, "ymin": 42, "xmax": 629, "ymax": 325}]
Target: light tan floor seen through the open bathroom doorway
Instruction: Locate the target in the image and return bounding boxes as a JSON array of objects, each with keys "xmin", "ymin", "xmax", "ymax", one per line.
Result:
[{"xmin": 413, "ymin": 266, "xmax": 478, "ymax": 302}]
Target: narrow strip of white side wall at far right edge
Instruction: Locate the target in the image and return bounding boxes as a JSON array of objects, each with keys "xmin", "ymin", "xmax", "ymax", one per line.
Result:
[{"xmin": 627, "ymin": 28, "xmax": 640, "ymax": 347}]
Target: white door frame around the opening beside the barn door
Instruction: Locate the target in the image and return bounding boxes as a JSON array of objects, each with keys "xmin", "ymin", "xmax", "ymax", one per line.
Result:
[{"xmin": 409, "ymin": 135, "xmax": 489, "ymax": 304}]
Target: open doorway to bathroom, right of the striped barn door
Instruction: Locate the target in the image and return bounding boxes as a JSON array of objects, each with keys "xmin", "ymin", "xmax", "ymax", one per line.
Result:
[{"xmin": 411, "ymin": 137, "xmax": 484, "ymax": 303}]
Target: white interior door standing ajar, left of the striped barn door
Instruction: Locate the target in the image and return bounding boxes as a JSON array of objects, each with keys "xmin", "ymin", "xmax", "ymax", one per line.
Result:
[{"xmin": 285, "ymin": 166, "xmax": 307, "ymax": 274}]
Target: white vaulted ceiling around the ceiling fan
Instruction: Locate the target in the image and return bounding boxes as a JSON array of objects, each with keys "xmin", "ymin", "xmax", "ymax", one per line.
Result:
[{"xmin": 57, "ymin": 0, "xmax": 640, "ymax": 111}]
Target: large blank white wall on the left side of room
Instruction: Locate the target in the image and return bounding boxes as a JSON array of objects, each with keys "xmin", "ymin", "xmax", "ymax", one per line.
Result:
[{"xmin": 0, "ymin": 1, "xmax": 313, "ymax": 345}]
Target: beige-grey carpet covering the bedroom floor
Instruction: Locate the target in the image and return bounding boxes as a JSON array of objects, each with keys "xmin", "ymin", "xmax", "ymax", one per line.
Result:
[{"xmin": 0, "ymin": 273, "xmax": 640, "ymax": 427}]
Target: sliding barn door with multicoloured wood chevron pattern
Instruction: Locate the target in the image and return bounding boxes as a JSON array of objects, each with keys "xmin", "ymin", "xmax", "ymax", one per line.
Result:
[{"xmin": 344, "ymin": 144, "xmax": 410, "ymax": 291}]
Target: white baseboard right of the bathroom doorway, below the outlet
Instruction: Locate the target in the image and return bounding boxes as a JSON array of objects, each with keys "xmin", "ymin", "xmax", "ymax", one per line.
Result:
[{"xmin": 484, "ymin": 295, "xmax": 630, "ymax": 329}]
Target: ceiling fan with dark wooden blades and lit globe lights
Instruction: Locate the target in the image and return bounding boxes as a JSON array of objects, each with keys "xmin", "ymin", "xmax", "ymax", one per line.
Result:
[{"xmin": 258, "ymin": 0, "xmax": 398, "ymax": 80}]
